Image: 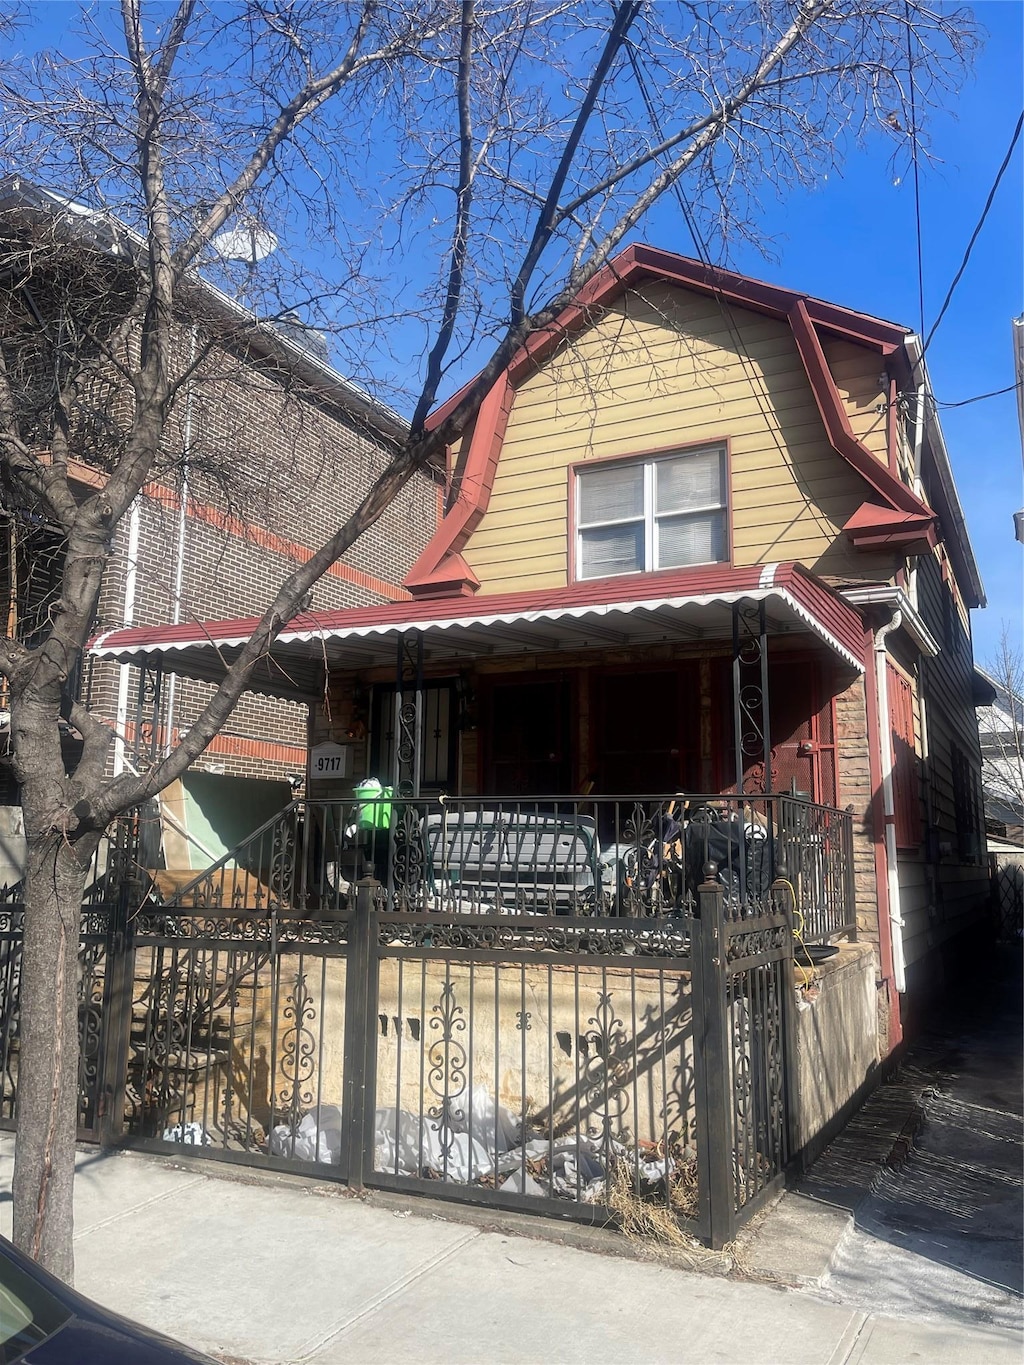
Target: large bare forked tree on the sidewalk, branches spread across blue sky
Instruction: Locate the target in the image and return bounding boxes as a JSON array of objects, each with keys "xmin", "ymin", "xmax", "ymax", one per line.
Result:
[{"xmin": 0, "ymin": 0, "xmax": 975, "ymax": 1279}]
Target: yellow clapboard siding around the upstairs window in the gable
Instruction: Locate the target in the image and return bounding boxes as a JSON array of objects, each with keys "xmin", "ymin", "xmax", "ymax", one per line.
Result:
[{"xmin": 463, "ymin": 285, "xmax": 893, "ymax": 592}]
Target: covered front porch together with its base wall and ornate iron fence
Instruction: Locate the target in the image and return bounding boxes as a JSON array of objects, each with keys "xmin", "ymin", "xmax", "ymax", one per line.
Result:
[{"xmin": 0, "ymin": 566, "xmax": 877, "ymax": 1245}]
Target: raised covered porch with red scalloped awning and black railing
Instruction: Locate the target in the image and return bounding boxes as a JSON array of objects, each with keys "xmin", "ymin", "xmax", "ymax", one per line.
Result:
[{"xmin": 96, "ymin": 554, "xmax": 874, "ymax": 942}]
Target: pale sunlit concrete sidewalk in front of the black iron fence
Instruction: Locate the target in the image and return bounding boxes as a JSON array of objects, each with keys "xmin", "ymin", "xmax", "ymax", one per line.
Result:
[{"xmin": 0, "ymin": 1134, "xmax": 1021, "ymax": 1365}]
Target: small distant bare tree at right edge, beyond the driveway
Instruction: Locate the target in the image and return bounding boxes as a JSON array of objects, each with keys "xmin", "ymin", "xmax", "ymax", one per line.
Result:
[{"xmin": 978, "ymin": 625, "xmax": 1024, "ymax": 842}]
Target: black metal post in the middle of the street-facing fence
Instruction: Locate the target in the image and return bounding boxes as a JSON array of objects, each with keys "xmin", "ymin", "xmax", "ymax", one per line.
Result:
[{"xmin": 341, "ymin": 876, "xmax": 381, "ymax": 1190}]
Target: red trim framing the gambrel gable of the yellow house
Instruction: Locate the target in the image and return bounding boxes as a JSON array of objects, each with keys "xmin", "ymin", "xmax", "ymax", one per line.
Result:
[{"xmin": 406, "ymin": 244, "xmax": 935, "ymax": 597}]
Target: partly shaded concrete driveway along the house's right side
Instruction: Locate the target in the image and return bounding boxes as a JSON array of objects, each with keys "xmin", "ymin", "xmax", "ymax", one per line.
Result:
[{"xmin": 741, "ymin": 945, "xmax": 1024, "ymax": 1337}]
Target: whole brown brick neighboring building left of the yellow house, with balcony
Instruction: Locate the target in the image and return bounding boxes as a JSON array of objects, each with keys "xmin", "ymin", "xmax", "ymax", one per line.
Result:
[{"xmin": 0, "ymin": 177, "xmax": 438, "ymax": 804}]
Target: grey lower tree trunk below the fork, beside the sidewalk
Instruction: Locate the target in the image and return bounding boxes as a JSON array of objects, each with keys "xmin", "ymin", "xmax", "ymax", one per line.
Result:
[{"xmin": 14, "ymin": 834, "xmax": 86, "ymax": 1284}]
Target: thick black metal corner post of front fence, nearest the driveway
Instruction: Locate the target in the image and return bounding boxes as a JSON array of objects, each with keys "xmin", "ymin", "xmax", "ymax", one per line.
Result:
[{"xmin": 692, "ymin": 863, "xmax": 736, "ymax": 1250}]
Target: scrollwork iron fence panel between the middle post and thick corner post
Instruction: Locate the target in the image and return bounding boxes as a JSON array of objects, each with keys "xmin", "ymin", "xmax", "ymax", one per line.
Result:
[{"xmin": 363, "ymin": 895, "xmax": 698, "ymax": 1227}]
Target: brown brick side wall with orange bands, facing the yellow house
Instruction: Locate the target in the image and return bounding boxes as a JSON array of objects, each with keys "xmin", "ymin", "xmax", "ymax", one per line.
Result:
[{"xmin": 86, "ymin": 327, "xmax": 438, "ymax": 777}]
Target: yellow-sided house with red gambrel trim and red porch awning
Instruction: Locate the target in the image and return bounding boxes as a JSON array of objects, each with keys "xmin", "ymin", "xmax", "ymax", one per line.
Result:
[{"xmin": 101, "ymin": 246, "xmax": 987, "ymax": 1055}]
